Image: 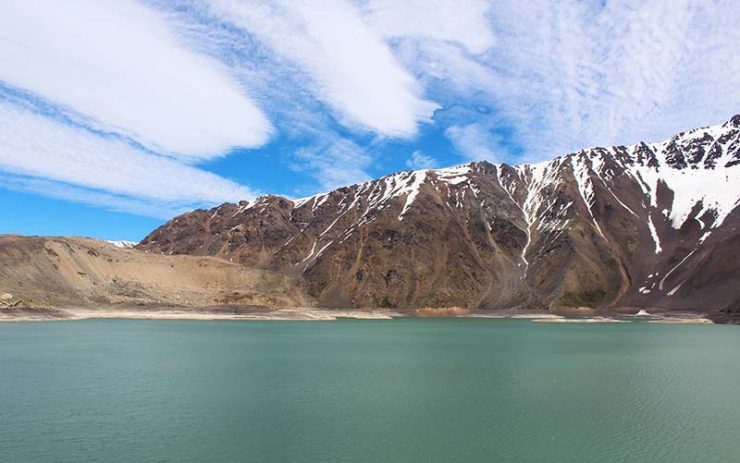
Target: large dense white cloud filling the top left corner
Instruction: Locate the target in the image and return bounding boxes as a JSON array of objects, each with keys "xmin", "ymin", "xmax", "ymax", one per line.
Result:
[{"xmin": 0, "ymin": 0, "xmax": 271, "ymax": 159}]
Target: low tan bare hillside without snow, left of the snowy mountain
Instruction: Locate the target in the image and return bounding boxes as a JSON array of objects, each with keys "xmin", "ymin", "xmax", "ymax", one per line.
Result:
[{"xmin": 0, "ymin": 235, "xmax": 312, "ymax": 308}]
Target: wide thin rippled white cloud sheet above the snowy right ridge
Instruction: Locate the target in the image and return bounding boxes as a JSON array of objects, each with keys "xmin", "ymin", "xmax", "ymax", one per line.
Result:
[{"xmin": 354, "ymin": 0, "xmax": 740, "ymax": 160}]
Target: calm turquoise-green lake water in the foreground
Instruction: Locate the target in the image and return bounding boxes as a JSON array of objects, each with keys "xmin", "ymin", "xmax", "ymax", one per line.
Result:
[{"xmin": 0, "ymin": 319, "xmax": 740, "ymax": 462}]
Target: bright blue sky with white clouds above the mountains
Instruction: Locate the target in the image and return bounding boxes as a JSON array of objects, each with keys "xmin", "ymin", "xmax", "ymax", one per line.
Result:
[{"xmin": 0, "ymin": 0, "xmax": 740, "ymax": 241}]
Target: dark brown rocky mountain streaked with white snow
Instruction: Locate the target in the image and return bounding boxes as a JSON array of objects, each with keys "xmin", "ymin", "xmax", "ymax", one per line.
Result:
[{"xmin": 137, "ymin": 115, "xmax": 740, "ymax": 320}]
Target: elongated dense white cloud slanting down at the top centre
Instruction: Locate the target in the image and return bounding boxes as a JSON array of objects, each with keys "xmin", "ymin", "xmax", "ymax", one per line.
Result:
[{"xmin": 210, "ymin": 0, "xmax": 437, "ymax": 137}]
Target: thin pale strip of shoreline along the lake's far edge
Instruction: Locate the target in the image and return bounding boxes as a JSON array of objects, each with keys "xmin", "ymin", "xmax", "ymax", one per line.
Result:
[{"xmin": 0, "ymin": 306, "xmax": 715, "ymax": 324}]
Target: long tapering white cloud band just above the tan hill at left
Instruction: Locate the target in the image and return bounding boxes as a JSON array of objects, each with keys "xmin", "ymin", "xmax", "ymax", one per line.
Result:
[{"xmin": 0, "ymin": 102, "xmax": 253, "ymax": 218}]
